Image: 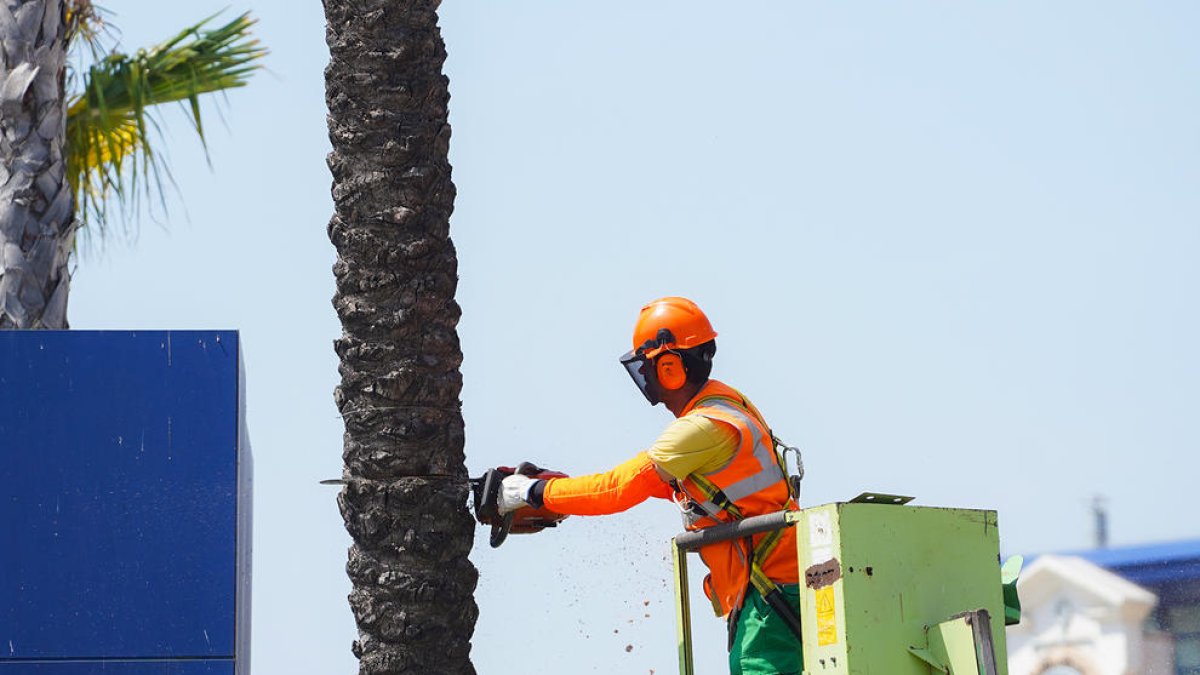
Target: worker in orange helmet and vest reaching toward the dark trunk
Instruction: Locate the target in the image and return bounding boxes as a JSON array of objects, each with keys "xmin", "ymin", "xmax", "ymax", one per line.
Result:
[{"xmin": 499, "ymin": 298, "xmax": 803, "ymax": 675}]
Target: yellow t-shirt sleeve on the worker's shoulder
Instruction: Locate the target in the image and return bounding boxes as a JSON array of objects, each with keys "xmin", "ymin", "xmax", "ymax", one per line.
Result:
[{"xmin": 647, "ymin": 414, "xmax": 738, "ymax": 480}]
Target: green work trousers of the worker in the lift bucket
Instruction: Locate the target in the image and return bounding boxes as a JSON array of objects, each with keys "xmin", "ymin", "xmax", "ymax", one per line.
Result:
[{"xmin": 730, "ymin": 584, "xmax": 804, "ymax": 675}]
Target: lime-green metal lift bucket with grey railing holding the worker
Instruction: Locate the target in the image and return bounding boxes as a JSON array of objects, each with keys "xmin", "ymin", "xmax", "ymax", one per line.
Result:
[{"xmin": 672, "ymin": 492, "xmax": 1020, "ymax": 675}]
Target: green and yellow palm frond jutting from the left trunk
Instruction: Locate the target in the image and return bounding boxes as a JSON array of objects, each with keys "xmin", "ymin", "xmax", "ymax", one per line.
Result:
[{"xmin": 67, "ymin": 13, "xmax": 266, "ymax": 236}]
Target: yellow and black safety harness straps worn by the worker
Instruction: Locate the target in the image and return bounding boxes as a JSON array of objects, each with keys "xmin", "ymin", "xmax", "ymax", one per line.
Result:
[{"xmin": 688, "ymin": 395, "xmax": 802, "ymax": 649}]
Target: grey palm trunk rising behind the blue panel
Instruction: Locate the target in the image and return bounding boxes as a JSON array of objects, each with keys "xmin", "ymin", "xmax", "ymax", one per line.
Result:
[{"xmin": 0, "ymin": 0, "xmax": 77, "ymax": 328}]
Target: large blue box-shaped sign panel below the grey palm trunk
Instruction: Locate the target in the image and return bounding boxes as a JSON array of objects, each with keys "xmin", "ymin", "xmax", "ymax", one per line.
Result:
[{"xmin": 0, "ymin": 331, "xmax": 251, "ymax": 675}]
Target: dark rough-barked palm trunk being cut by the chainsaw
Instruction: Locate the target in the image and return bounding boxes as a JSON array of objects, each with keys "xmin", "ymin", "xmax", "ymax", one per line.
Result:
[{"xmin": 324, "ymin": 0, "xmax": 478, "ymax": 675}]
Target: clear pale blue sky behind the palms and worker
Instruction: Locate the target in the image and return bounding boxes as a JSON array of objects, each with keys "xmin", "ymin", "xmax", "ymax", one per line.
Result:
[{"xmin": 71, "ymin": 0, "xmax": 1200, "ymax": 675}]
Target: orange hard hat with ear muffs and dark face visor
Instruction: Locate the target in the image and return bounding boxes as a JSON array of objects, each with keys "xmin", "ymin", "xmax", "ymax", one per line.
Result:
[{"xmin": 620, "ymin": 297, "xmax": 716, "ymax": 405}]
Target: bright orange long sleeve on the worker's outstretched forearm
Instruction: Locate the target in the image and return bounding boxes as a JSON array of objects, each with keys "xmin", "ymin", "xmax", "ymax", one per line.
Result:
[{"xmin": 529, "ymin": 453, "xmax": 671, "ymax": 515}]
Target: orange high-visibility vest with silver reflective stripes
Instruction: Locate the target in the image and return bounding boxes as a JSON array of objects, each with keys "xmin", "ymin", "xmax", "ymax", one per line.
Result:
[{"xmin": 676, "ymin": 380, "xmax": 799, "ymax": 616}]
